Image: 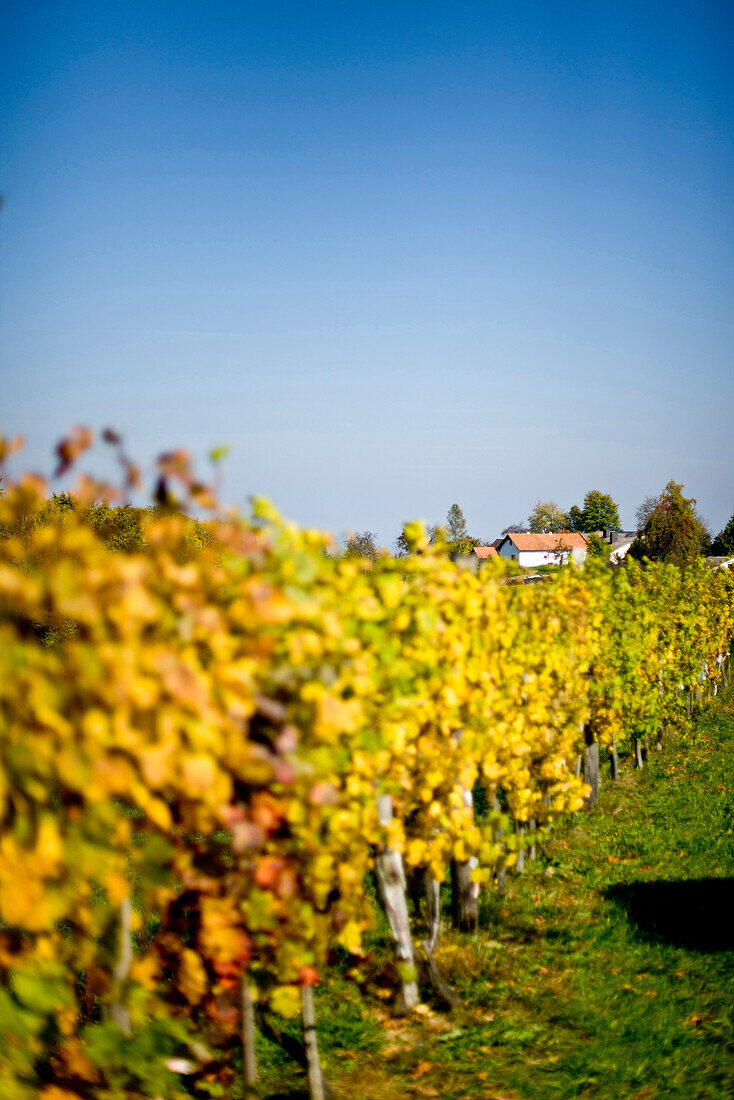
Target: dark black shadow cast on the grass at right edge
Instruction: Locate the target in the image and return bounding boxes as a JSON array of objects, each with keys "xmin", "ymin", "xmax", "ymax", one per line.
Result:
[{"xmin": 604, "ymin": 879, "xmax": 734, "ymax": 953}]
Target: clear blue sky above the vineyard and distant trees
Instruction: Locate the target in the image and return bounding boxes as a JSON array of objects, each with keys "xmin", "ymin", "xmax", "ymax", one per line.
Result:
[{"xmin": 0, "ymin": 0, "xmax": 734, "ymax": 546}]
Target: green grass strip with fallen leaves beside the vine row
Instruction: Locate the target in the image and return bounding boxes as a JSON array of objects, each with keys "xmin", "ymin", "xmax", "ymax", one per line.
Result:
[{"xmin": 250, "ymin": 696, "xmax": 734, "ymax": 1100}]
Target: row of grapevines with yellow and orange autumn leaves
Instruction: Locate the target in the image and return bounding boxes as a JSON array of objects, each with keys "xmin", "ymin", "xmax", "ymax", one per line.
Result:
[{"xmin": 0, "ymin": 433, "xmax": 734, "ymax": 1100}]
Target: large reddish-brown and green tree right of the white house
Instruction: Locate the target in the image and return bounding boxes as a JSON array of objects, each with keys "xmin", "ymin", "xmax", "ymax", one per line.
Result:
[{"xmin": 629, "ymin": 481, "xmax": 711, "ymax": 565}]
